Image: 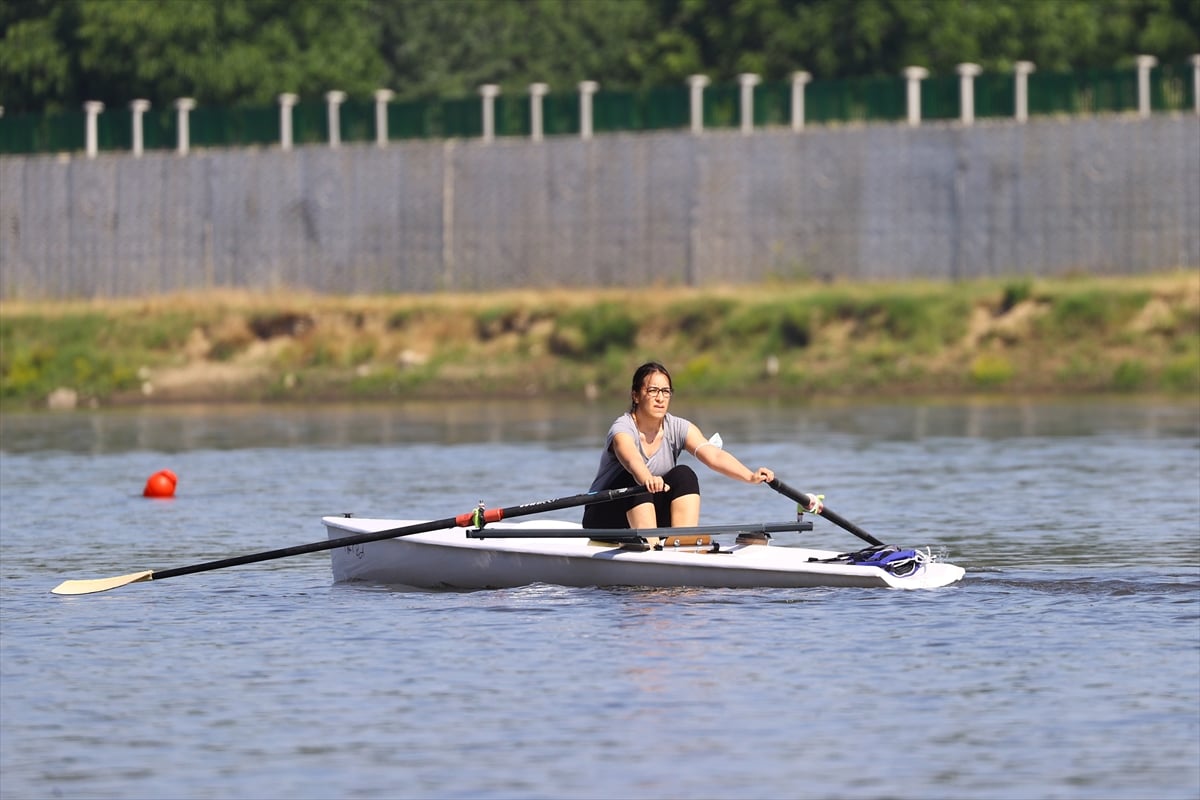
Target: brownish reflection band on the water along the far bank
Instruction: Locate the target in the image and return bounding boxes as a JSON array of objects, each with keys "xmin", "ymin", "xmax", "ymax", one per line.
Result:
[{"xmin": 0, "ymin": 397, "xmax": 1200, "ymax": 453}]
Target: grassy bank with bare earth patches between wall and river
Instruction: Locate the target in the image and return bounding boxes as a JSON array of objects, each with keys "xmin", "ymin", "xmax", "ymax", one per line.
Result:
[{"xmin": 0, "ymin": 270, "xmax": 1200, "ymax": 411}]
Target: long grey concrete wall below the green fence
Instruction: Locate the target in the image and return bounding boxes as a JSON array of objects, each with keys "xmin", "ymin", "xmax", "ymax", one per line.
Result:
[{"xmin": 0, "ymin": 115, "xmax": 1200, "ymax": 299}]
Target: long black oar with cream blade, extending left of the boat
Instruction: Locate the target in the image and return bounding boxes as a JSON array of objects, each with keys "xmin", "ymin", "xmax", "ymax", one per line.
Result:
[{"xmin": 50, "ymin": 486, "xmax": 646, "ymax": 595}]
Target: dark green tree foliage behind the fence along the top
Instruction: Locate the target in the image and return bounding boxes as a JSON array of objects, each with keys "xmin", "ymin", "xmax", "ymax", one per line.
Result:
[{"xmin": 0, "ymin": 0, "xmax": 1200, "ymax": 112}]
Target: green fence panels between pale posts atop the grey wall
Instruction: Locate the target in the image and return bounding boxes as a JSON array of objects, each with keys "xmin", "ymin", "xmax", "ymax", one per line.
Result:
[{"xmin": 0, "ymin": 64, "xmax": 1195, "ymax": 155}]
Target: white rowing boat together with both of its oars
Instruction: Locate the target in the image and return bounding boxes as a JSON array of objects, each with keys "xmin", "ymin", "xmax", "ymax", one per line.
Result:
[{"xmin": 50, "ymin": 479, "xmax": 964, "ymax": 596}]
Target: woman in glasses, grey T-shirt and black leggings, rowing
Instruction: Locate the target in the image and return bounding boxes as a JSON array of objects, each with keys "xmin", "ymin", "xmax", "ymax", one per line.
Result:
[{"xmin": 583, "ymin": 361, "xmax": 821, "ymax": 537}]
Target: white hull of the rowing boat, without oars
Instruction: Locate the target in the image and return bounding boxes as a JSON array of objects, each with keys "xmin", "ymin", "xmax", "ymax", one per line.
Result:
[{"xmin": 323, "ymin": 517, "xmax": 964, "ymax": 589}]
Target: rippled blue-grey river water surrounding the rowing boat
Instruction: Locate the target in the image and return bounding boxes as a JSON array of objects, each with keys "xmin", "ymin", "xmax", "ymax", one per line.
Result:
[{"xmin": 0, "ymin": 398, "xmax": 1200, "ymax": 800}]
